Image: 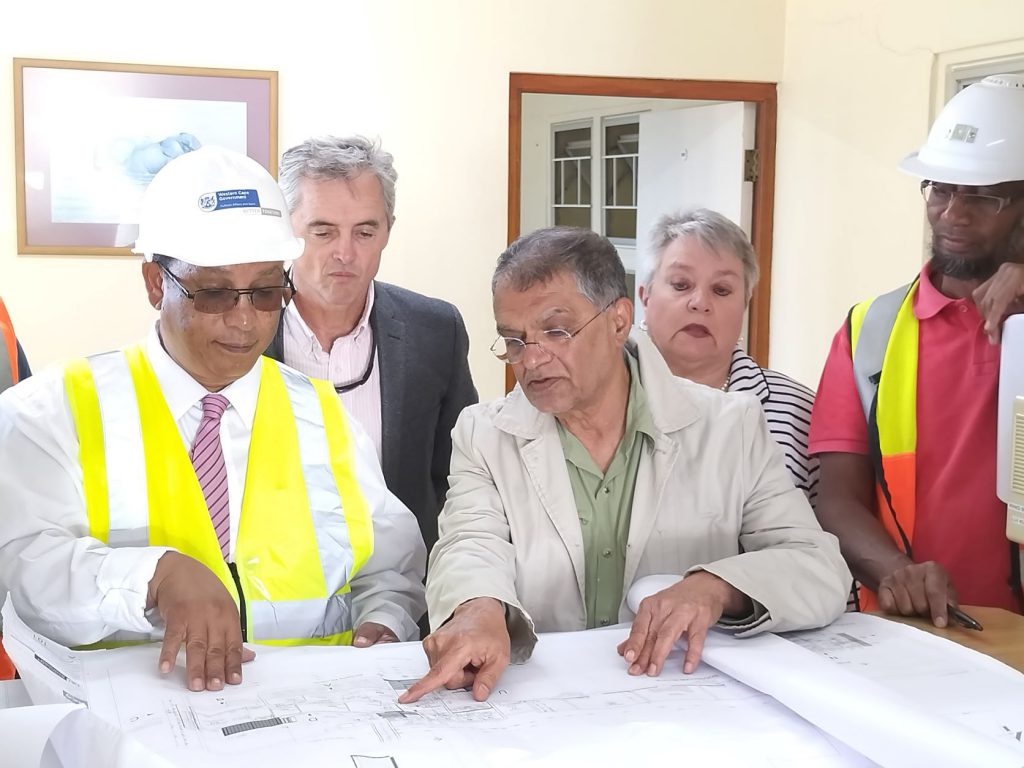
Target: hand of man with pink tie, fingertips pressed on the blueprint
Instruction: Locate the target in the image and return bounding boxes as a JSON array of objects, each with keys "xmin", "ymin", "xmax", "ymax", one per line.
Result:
[{"xmin": 148, "ymin": 552, "xmax": 256, "ymax": 691}]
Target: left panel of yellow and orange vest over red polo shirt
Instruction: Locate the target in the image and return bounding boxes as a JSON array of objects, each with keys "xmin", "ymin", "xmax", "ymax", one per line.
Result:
[{"xmin": 848, "ymin": 281, "xmax": 919, "ymax": 609}]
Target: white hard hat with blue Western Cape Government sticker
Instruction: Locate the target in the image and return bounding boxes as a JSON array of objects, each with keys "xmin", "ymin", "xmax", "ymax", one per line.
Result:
[{"xmin": 132, "ymin": 146, "xmax": 302, "ymax": 266}]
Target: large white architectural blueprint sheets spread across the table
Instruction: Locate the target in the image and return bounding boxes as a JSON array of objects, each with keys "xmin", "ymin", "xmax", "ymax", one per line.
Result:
[{"xmin": 4, "ymin": 608, "xmax": 1024, "ymax": 768}]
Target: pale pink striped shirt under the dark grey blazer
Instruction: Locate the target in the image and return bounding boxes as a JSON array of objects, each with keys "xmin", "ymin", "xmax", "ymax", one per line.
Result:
[{"xmin": 282, "ymin": 282, "xmax": 382, "ymax": 461}]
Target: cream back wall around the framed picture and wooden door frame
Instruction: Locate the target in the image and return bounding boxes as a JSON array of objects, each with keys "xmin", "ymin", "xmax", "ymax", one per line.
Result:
[{"xmin": 0, "ymin": 0, "xmax": 784, "ymax": 398}]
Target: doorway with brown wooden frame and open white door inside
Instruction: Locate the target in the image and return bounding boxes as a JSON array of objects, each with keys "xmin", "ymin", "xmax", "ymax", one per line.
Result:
[{"xmin": 506, "ymin": 73, "xmax": 776, "ymax": 389}]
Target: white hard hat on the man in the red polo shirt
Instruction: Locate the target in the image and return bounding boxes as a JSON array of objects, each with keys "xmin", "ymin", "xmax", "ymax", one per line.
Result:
[{"xmin": 899, "ymin": 75, "xmax": 1024, "ymax": 186}]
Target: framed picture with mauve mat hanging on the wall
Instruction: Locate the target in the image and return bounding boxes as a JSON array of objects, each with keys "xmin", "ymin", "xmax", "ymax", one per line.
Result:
[{"xmin": 14, "ymin": 58, "xmax": 278, "ymax": 256}]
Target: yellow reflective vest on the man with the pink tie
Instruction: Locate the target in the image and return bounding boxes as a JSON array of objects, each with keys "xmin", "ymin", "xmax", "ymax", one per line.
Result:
[{"xmin": 65, "ymin": 347, "xmax": 373, "ymax": 644}]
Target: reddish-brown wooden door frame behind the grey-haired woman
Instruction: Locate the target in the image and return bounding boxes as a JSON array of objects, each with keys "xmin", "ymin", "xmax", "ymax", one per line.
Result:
[{"xmin": 505, "ymin": 72, "xmax": 778, "ymax": 390}]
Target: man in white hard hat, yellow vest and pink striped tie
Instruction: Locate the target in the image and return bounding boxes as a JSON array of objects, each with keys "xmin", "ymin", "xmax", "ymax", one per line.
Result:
[{"xmin": 0, "ymin": 147, "xmax": 426, "ymax": 690}]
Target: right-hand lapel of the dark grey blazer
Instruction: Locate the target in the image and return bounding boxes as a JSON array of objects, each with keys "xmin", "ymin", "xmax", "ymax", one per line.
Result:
[{"xmin": 370, "ymin": 282, "xmax": 409, "ymax": 486}]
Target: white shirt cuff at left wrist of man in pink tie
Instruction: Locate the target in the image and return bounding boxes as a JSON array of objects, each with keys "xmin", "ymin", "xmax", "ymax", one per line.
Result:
[{"xmin": 96, "ymin": 547, "xmax": 171, "ymax": 633}]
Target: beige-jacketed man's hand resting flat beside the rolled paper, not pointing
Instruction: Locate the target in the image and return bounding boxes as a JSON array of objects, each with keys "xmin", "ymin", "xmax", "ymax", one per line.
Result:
[{"xmin": 618, "ymin": 570, "xmax": 748, "ymax": 677}]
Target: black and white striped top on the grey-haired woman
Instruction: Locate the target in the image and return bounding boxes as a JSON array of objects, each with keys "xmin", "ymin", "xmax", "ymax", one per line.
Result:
[{"xmin": 728, "ymin": 347, "xmax": 818, "ymax": 508}]
